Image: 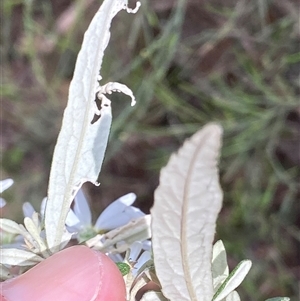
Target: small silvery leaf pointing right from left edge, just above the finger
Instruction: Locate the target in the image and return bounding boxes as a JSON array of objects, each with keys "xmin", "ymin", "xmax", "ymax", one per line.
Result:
[{"xmin": 0, "ymin": 249, "xmax": 43, "ymax": 266}]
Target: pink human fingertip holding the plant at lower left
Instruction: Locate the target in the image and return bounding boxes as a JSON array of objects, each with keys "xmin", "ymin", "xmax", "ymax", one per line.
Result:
[{"xmin": 0, "ymin": 246, "xmax": 126, "ymax": 301}]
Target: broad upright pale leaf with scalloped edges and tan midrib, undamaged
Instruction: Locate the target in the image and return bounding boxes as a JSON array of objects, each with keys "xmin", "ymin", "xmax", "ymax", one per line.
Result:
[{"xmin": 151, "ymin": 124, "xmax": 223, "ymax": 301}]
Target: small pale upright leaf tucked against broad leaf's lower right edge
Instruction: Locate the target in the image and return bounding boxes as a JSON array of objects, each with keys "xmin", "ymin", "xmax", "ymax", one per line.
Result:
[{"xmin": 212, "ymin": 240, "xmax": 229, "ymax": 291}]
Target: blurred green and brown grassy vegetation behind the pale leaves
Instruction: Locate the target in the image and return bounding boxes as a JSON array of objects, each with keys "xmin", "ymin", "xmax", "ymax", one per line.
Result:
[{"xmin": 1, "ymin": 0, "xmax": 300, "ymax": 300}]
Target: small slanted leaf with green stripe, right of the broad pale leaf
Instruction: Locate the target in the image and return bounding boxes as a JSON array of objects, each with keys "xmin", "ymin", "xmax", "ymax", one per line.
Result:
[{"xmin": 213, "ymin": 260, "xmax": 252, "ymax": 301}]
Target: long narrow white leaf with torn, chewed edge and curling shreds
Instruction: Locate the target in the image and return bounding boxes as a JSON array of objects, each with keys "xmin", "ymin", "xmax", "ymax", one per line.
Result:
[{"xmin": 45, "ymin": 0, "xmax": 139, "ymax": 252}]
